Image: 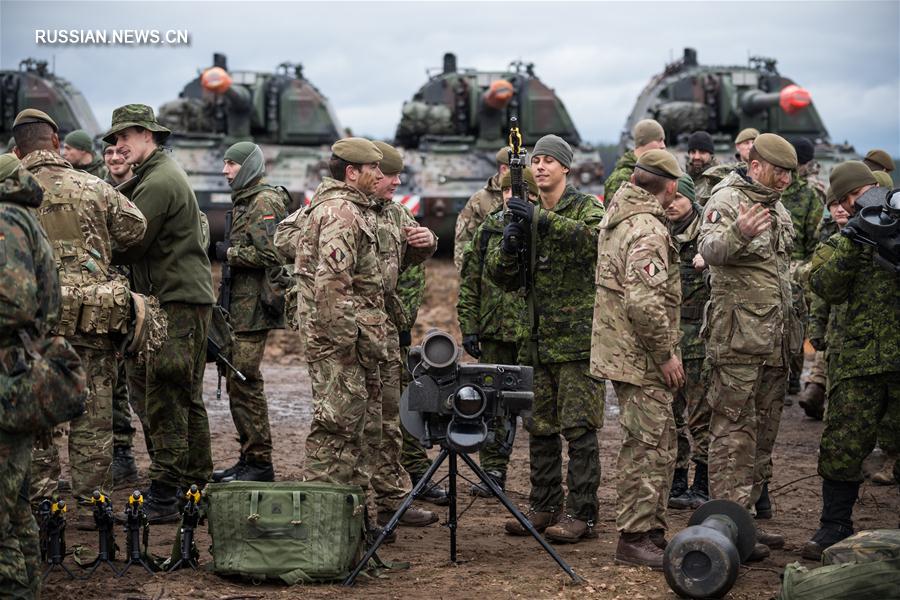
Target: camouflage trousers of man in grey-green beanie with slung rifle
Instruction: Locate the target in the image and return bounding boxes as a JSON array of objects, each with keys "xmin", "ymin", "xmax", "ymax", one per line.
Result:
[{"xmin": 225, "ymin": 330, "xmax": 272, "ymax": 463}]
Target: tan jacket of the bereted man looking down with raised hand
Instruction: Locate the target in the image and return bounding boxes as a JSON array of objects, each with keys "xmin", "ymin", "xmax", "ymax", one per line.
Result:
[{"xmin": 699, "ymin": 166, "xmax": 802, "ymax": 366}]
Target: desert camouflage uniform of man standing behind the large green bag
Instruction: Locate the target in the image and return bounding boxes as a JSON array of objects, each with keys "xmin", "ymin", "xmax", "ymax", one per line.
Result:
[{"xmin": 294, "ymin": 177, "xmax": 389, "ymax": 489}]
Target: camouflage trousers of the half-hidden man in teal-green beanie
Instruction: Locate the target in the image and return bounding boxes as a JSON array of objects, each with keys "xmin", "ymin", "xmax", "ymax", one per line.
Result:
[{"xmin": 672, "ymin": 358, "xmax": 710, "ymax": 469}]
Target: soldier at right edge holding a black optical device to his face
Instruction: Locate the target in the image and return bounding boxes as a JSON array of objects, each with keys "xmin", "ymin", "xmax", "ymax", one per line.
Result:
[{"xmin": 803, "ymin": 161, "xmax": 900, "ymax": 560}]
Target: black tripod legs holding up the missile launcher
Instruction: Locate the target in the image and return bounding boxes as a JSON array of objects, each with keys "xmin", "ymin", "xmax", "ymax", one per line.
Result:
[{"xmin": 344, "ymin": 444, "xmax": 584, "ymax": 586}]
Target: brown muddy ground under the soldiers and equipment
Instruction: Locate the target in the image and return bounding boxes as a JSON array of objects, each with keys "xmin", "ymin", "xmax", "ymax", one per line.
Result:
[{"xmin": 43, "ymin": 259, "xmax": 900, "ymax": 600}]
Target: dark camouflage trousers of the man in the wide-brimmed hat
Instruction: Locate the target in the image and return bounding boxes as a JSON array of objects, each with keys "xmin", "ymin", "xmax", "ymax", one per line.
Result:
[{"xmin": 145, "ymin": 302, "xmax": 212, "ymax": 488}]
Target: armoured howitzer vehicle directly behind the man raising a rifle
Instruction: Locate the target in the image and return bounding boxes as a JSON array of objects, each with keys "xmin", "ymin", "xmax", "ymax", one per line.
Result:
[{"xmin": 395, "ymin": 53, "xmax": 603, "ymax": 249}]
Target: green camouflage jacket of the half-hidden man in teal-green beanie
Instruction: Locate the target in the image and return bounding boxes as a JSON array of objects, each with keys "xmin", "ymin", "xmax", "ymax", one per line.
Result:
[{"xmin": 670, "ymin": 205, "xmax": 709, "ymax": 360}]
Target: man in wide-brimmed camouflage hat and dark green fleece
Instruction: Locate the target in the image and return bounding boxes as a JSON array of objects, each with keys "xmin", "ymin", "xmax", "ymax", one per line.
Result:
[{"xmin": 103, "ymin": 104, "xmax": 214, "ymax": 523}]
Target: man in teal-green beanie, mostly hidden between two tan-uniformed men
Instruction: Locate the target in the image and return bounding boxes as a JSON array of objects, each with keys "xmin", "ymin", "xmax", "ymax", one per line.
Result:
[{"xmin": 666, "ymin": 174, "xmax": 710, "ymax": 509}]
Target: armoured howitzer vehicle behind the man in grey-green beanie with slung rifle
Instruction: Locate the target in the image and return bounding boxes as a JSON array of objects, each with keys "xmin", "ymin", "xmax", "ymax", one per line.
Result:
[{"xmin": 158, "ymin": 54, "xmax": 344, "ymax": 240}]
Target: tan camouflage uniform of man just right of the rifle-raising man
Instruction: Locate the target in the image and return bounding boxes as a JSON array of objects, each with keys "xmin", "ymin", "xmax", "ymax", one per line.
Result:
[{"xmin": 591, "ymin": 183, "xmax": 681, "ymax": 533}]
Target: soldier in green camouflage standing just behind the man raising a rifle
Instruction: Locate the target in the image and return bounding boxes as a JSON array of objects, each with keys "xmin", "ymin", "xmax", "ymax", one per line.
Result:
[{"xmin": 456, "ymin": 168, "xmax": 540, "ymax": 498}]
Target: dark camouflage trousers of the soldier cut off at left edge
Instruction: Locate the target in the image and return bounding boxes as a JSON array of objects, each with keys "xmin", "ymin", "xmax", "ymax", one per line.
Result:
[{"xmin": 0, "ymin": 433, "xmax": 41, "ymax": 599}]
